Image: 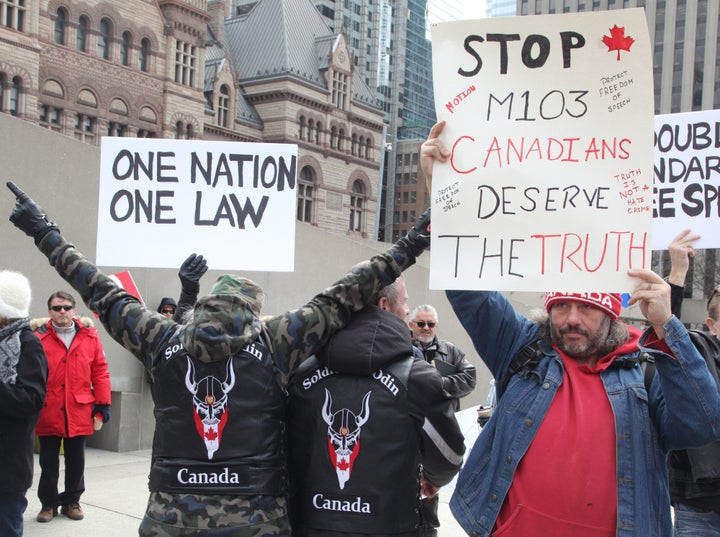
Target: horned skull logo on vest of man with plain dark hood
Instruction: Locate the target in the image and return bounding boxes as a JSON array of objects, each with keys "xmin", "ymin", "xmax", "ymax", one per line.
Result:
[{"xmin": 322, "ymin": 388, "xmax": 372, "ymax": 489}]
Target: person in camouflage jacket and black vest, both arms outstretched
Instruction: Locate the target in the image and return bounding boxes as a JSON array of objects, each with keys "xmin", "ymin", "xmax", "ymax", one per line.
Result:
[{"xmin": 8, "ymin": 183, "xmax": 430, "ymax": 537}]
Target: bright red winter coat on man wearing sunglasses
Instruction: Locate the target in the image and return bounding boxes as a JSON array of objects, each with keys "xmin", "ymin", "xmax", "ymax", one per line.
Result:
[{"xmin": 35, "ymin": 317, "xmax": 110, "ymax": 438}]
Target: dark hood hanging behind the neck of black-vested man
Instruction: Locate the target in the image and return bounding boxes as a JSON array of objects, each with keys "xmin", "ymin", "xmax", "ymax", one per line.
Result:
[{"xmin": 318, "ymin": 306, "xmax": 413, "ymax": 375}]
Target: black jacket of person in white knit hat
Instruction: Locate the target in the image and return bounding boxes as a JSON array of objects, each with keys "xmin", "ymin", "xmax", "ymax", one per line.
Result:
[{"xmin": 0, "ymin": 323, "xmax": 47, "ymax": 493}]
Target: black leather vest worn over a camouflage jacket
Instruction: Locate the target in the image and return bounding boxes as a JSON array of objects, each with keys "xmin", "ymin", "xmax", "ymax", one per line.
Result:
[{"xmin": 150, "ymin": 331, "xmax": 286, "ymax": 496}]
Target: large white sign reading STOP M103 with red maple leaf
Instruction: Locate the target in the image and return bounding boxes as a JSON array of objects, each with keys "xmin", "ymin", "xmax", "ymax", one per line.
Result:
[{"xmin": 430, "ymin": 9, "xmax": 653, "ymax": 292}]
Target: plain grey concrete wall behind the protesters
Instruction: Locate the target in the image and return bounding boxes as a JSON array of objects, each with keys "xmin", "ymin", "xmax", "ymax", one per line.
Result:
[{"xmin": 0, "ymin": 114, "xmax": 506, "ymax": 451}]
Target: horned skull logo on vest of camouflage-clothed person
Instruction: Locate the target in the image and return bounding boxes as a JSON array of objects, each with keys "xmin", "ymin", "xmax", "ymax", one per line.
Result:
[{"xmin": 185, "ymin": 358, "xmax": 235, "ymax": 459}]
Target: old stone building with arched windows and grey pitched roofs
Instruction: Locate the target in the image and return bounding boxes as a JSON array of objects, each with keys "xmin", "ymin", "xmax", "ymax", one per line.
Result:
[{"xmin": 0, "ymin": 0, "xmax": 384, "ymax": 238}]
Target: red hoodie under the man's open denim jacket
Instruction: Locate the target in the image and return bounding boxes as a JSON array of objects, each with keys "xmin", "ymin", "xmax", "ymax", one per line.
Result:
[{"xmin": 493, "ymin": 327, "xmax": 641, "ymax": 537}]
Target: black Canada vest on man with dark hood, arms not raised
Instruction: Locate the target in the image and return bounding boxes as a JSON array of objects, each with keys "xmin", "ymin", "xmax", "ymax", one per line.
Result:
[{"xmin": 288, "ymin": 357, "xmax": 419, "ymax": 533}]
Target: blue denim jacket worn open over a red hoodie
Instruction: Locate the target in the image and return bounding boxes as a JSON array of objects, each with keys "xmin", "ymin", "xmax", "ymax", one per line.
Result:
[{"xmin": 447, "ymin": 291, "xmax": 720, "ymax": 537}]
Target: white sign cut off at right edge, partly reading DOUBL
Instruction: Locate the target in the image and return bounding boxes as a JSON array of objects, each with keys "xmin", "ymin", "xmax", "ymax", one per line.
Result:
[{"xmin": 653, "ymin": 110, "xmax": 720, "ymax": 250}]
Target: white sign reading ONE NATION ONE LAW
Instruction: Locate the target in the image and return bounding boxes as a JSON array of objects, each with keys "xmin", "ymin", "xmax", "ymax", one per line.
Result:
[{"xmin": 97, "ymin": 137, "xmax": 297, "ymax": 271}]
